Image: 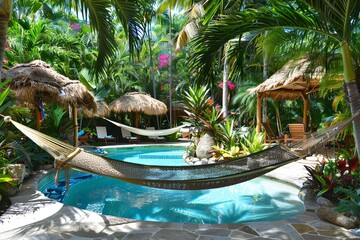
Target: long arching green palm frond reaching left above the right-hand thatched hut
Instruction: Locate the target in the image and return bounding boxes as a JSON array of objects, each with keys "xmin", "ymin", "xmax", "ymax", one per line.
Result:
[{"xmin": 189, "ymin": 1, "xmax": 336, "ymax": 82}]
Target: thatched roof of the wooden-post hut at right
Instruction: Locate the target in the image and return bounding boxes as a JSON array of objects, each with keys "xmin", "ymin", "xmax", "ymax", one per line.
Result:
[{"xmin": 248, "ymin": 56, "xmax": 324, "ymax": 100}]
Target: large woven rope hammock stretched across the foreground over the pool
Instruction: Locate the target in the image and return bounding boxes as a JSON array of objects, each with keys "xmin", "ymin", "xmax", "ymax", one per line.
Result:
[{"xmin": 5, "ymin": 112, "xmax": 360, "ymax": 190}]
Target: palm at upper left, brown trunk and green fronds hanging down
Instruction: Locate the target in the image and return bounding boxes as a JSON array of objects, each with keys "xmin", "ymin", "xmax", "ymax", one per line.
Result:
[{"xmin": 0, "ymin": 0, "xmax": 147, "ymax": 75}]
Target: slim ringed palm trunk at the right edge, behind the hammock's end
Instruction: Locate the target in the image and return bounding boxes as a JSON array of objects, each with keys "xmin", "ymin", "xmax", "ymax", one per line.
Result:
[{"xmin": 341, "ymin": 41, "xmax": 360, "ymax": 154}]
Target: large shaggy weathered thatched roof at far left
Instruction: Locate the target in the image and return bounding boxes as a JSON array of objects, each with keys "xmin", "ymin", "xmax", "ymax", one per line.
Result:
[{"xmin": 2, "ymin": 60, "xmax": 97, "ymax": 112}]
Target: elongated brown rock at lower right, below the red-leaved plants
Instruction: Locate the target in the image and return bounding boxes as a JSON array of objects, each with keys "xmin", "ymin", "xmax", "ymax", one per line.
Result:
[{"xmin": 316, "ymin": 206, "xmax": 357, "ymax": 229}]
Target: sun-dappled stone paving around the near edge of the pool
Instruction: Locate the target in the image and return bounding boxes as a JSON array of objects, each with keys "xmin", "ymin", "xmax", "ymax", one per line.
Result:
[{"xmin": 0, "ymin": 143, "xmax": 360, "ymax": 240}]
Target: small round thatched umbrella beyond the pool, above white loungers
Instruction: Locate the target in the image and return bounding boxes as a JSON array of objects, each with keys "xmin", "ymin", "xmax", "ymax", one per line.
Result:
[{"xmin": 109, "ymin": 92, "xmax": 167, "ymax": 127}]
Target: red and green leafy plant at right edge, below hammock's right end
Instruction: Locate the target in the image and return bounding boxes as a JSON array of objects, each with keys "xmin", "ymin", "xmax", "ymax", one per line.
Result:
[{"xmin": 305, "ymin": 151, "xmax": 360, "ymax": 202}]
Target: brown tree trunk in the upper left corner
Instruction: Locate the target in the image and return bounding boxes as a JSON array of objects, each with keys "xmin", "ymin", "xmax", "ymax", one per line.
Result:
[{"xmin": 0, "ymin": 0, "xmax": 12, "ymax": 75}]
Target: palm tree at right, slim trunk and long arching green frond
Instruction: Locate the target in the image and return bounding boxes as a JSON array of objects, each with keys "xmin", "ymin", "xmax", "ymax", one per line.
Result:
[{"xmin": 191, "ymin": 0, "xmax": 360, "ymax": 152}]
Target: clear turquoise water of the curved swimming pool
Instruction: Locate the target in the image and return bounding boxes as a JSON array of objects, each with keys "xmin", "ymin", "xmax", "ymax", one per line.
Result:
[{"xmin": 39, "ymin": 147, "xmax": 304, "ymax": 223}]
